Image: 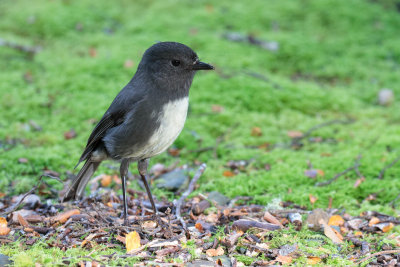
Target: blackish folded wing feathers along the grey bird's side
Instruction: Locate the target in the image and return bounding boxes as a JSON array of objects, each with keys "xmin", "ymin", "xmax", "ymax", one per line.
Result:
[{"xmin": 76, "ymin": 109, "xmax": 126, "ymax": 166}]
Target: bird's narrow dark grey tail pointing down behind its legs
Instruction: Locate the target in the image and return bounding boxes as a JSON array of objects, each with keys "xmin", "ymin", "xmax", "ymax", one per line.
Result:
[{"xmin": 61, "ymin": 159, "xmax": 101, "ymax": 202}]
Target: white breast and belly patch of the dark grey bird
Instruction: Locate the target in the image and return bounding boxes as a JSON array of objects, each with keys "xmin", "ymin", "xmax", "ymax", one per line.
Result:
[{"xmin": 138, "ymin": 97, "xmax": 189, "ymax": 157}]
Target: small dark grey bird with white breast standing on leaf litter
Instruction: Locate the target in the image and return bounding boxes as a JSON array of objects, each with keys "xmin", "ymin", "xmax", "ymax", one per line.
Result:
[{"xmin": 62, "ymin": 42, "xmax": 214, "ymax": 225}]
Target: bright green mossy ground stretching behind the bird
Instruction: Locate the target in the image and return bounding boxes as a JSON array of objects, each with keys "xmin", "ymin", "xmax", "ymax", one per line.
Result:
[{"xmin": 0, "ymin": 0, "xmax": 400, "ymax": 263}]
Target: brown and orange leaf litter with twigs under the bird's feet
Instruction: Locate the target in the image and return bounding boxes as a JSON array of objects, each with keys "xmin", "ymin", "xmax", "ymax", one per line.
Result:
[{"xmin": 0, "ymin": 163, "xmax": 400, "ymax": 266}]
